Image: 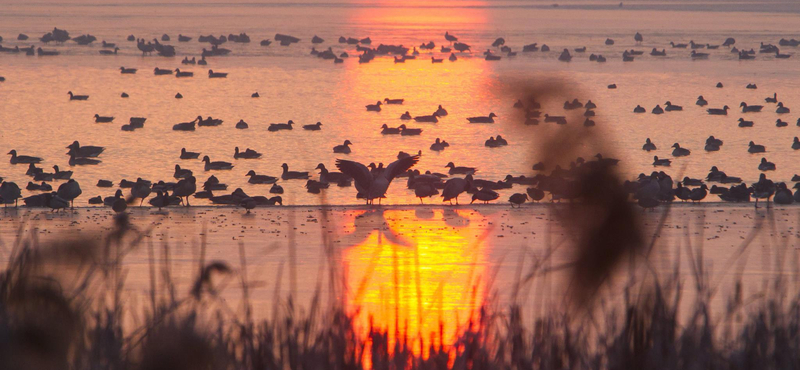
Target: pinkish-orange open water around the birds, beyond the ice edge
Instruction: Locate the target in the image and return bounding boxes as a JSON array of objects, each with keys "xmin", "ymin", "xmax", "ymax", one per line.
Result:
[{"xmin": 0, "ymin": 1, "xmax": 800, "ymax": 204}]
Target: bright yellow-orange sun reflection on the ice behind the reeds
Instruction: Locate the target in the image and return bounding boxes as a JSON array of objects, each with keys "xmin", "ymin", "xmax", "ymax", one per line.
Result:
[{"xmin": 344, "ymin": 210, "xmax": 485, "ymax": 361}]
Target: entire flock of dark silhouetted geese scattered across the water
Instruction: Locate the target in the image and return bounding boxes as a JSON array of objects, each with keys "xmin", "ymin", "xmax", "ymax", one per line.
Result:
[{"xmin": 0, "ymin": 29, "xmax": 800, "ymax": 212}]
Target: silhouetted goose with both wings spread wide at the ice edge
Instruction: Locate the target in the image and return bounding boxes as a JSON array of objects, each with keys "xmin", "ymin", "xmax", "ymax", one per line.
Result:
[{"xmin": 336, "ymin": 155, "xmax": 419, "ymax": 204}]
